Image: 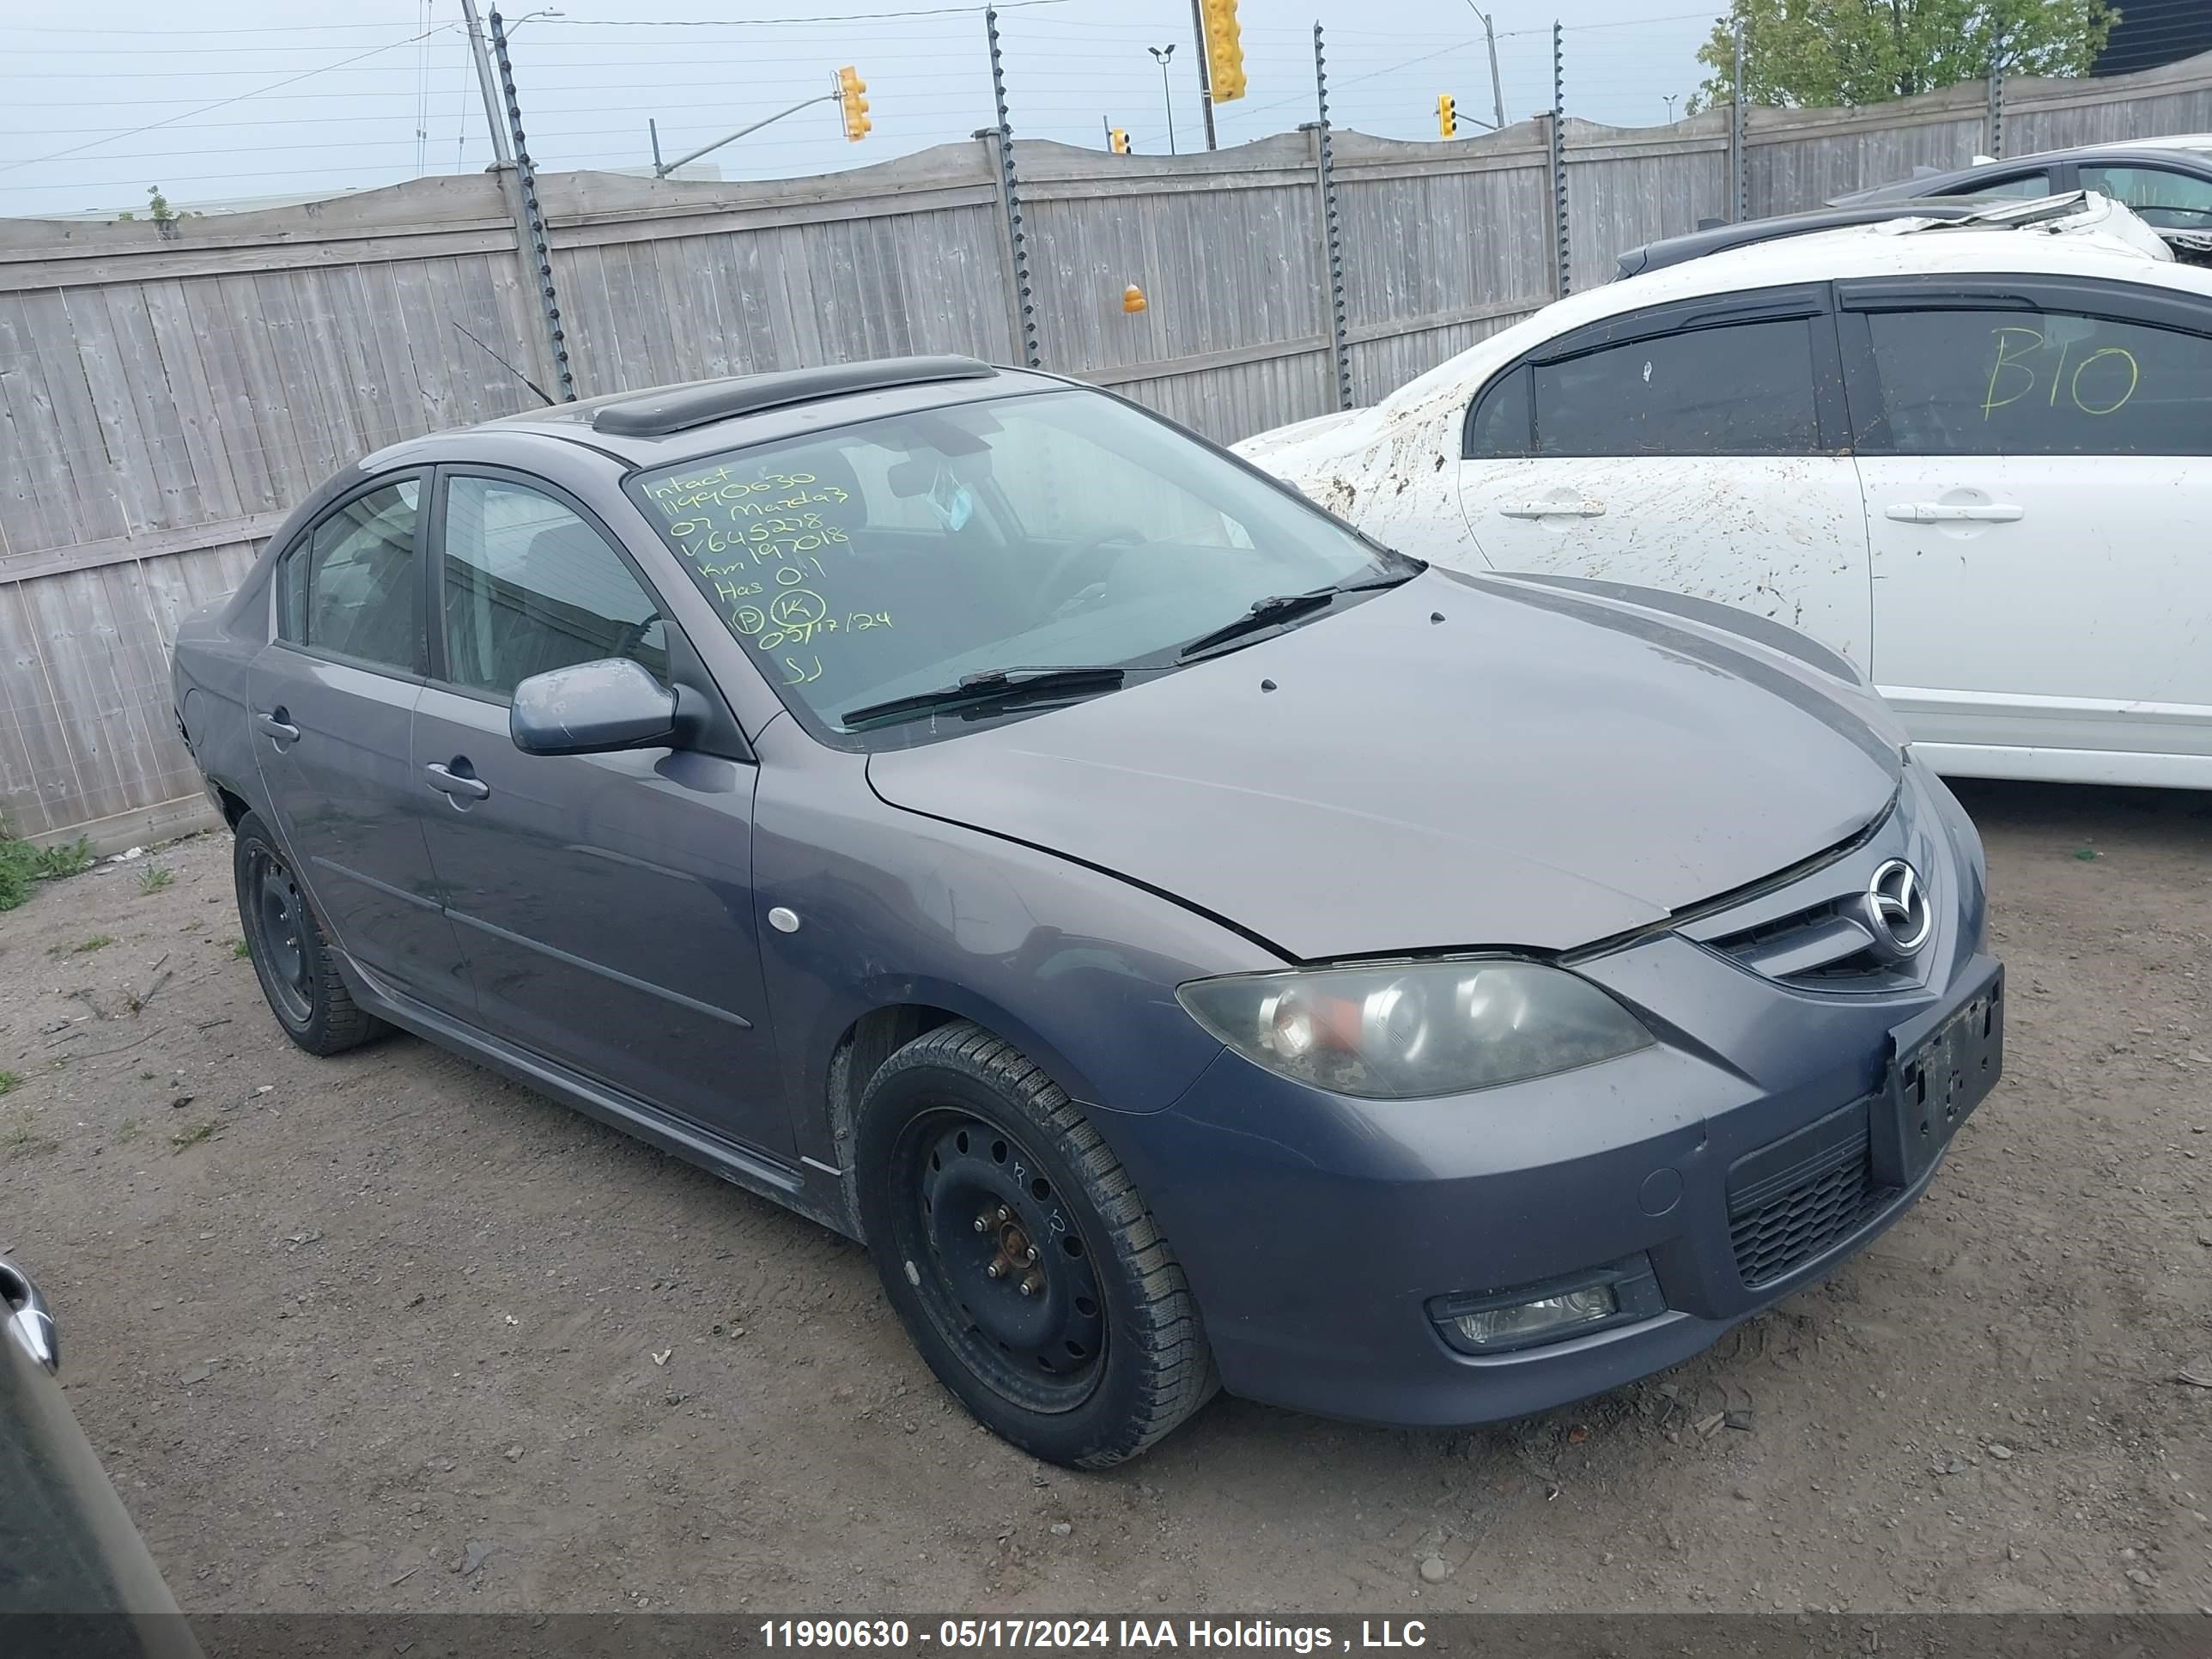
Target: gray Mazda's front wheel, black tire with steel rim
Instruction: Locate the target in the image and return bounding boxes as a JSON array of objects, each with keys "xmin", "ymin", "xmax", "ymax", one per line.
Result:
[{"xmin": 854, "ymin": 1020, "xmax": 1221, "ymax": 1468}]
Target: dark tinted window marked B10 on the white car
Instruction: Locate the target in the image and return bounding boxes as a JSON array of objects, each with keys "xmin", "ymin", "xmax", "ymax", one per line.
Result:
[{"xmin": 1867, "ymin": 310, "xmax": 2212, "ymax": 456}]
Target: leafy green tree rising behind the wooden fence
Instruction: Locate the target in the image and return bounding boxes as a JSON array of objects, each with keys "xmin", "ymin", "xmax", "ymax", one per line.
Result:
[{"xmin": 1697, "ymin": 0, "xmax": 2119, "ymax": 108}]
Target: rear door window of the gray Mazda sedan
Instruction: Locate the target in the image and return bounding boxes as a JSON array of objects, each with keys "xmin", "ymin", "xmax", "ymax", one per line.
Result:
[{"xmin": 276, "ymin": 477, "xmax": 422, "ymax": 675}]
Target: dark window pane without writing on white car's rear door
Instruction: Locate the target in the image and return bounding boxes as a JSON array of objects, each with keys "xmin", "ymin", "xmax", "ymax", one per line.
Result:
[{"xmin": 1533, "ymin": 316, "xmax": 1820, "ymax": 456}]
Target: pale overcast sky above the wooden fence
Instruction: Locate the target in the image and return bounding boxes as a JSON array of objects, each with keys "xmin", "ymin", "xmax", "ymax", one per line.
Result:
[{"xmin": 0, "ymin": 0, "xmax": 1723, "ymax": 216}]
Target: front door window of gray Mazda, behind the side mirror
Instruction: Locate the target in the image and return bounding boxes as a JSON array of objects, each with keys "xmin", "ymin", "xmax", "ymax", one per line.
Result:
[{"xmin": 438, "ymin": 477, "xmax": 668, "ymax": 696}]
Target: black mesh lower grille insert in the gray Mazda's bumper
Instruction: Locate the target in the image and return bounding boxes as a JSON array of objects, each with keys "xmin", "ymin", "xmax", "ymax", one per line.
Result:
[{"xmin": 1728, "ymin": 1102, "xmax": 1891, "ymax": 1287}]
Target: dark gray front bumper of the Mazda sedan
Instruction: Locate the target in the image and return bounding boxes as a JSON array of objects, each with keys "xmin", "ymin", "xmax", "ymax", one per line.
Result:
[{"xmin": 1099, "ymin": 779, "xmax": 2002, "ymax": 1425}]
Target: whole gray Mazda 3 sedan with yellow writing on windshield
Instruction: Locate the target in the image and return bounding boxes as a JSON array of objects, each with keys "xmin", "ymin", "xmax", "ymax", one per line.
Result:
[{"xmin": 175, "ymin": 358, "xmax": 2004, "ymax": 1468}]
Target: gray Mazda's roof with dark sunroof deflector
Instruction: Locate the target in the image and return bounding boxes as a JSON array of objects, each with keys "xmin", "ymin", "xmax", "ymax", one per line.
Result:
[{"xmin": 361, "ymin": 356, "xmax": 1078, "ymax": 469}]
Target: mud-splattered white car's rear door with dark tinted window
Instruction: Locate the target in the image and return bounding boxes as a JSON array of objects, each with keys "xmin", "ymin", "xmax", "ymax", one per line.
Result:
[{"xmin": 1458, "ymin": 288, "xmax": 1871, "ymax": 664}]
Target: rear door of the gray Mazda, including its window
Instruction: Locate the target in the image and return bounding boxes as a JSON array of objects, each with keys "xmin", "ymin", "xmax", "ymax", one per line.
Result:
[{"xmin": 248, "ymin": 471, "xmax": 467, "ymax": 1006}]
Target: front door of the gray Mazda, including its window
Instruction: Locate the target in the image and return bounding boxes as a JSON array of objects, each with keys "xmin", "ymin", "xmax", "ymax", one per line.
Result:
[{"xmin": 411, "ymin": 471, "xmax": 792, "ymax": 1152}]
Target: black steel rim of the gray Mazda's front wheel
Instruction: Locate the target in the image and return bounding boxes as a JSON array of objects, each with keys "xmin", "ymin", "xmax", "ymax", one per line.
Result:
[{"xmin": 894, "ymin": 1109, "xmax": 1109, "ymax": 1411}]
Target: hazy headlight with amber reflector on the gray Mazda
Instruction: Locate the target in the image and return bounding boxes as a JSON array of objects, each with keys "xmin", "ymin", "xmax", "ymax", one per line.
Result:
[{"xmin": 1175, "ymin": 960, "xmax": 1652, "ymax": 1099}]
